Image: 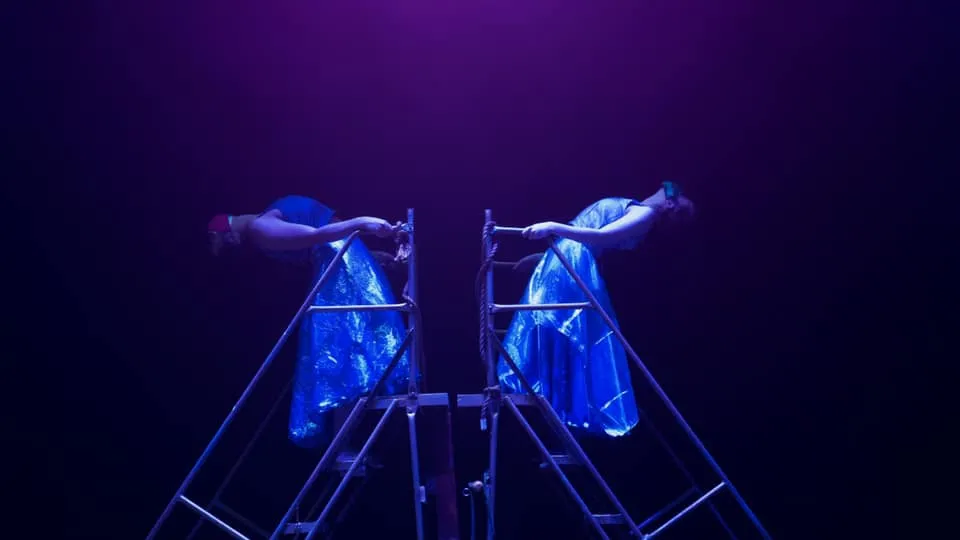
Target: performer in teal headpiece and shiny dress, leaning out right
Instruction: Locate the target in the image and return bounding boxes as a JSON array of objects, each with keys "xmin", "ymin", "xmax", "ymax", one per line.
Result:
[{"xmin": 498, "ymin": 182, "xmax": 693, "ymax": 437}]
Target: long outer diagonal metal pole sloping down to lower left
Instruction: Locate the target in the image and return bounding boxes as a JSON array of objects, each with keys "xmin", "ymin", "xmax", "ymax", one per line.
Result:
[{"xmin": 147, "ymin": 232, "xmax": 359, "ymax": 540}]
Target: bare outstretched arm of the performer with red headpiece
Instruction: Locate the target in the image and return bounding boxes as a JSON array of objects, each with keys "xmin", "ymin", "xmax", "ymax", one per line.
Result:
[{"xmin": 247, "ymin": 213, "xmax": 393, "ymax": 251}]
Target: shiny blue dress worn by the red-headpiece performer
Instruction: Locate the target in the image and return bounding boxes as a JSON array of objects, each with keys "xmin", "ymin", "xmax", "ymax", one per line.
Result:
[{"xmin": 260, "ymin": 196, "xmax": 409, "ymax": 448}]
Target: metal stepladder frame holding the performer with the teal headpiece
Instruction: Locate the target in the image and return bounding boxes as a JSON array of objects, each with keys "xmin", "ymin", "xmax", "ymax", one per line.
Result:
[{"xmin": 458, "ymin": 210, "xmax": 770, "ymax": 540}]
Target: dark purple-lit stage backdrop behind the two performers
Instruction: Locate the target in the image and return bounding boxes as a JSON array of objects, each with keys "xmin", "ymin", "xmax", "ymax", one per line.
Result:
[{"xmin": 3, "ymin": 0, "xmax": 956, "ymax": 539}]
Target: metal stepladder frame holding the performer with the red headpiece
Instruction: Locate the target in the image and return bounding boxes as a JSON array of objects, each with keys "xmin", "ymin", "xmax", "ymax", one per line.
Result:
[{"xmin": 147, "ymin": 209, "xmax": 436, "ymax": 540}]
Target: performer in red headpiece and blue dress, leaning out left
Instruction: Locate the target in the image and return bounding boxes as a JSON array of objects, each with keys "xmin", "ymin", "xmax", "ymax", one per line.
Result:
[{"xmin": 208, "ymin": 196, "xmax": 409, "ymax": 448}]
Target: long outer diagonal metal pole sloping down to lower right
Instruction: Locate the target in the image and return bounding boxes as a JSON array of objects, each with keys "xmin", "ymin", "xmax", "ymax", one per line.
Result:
[{"xmin": 550, "ymin": 240, "xmax": 770, "ymax": 540}]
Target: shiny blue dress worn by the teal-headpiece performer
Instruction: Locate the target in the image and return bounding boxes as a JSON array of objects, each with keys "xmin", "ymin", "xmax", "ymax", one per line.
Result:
[{"xmin": 498, "ymin": 198, "xmax": 640, "ymax": 437}]
